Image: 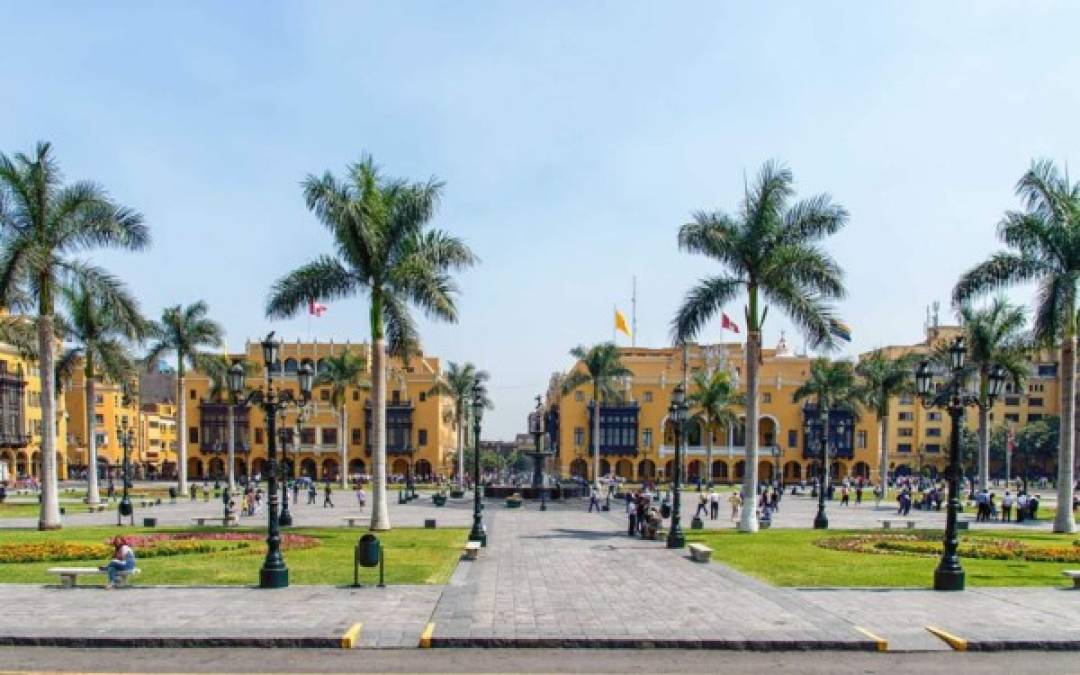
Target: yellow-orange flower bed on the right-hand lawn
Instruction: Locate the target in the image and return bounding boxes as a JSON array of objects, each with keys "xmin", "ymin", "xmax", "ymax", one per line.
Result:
[{"xmin": 814, "ymin": 532, "xmax": 1080, "ymax": 563}]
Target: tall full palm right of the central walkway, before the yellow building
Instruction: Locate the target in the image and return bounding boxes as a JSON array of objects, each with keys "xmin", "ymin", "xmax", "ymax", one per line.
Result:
[{"xmin": 672, "ymin": 162, "xmax": 848, "ymax": 532}]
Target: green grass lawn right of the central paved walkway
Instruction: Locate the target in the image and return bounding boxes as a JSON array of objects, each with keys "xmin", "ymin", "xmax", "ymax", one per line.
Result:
[{"xmin": 687, "ymin": 529, "xmax": 1080, "ymax": 588}]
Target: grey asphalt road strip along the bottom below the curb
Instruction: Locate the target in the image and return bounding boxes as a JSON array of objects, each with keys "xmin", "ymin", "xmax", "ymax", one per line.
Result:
[{"xmin": 0, "ymin": 647, "xmax": 1080, "ymax": 675}]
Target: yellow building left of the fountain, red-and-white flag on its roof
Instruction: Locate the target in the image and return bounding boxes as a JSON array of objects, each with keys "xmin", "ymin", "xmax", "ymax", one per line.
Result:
[{"xmin": 183, "ymin": 341, "xmax": 456, "ymax": 481}]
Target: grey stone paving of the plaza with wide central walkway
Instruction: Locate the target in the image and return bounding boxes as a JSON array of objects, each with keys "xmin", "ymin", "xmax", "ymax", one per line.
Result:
[{"xmin": 0, "ymin": 492, "xmax": 1080, "ymax": 651}]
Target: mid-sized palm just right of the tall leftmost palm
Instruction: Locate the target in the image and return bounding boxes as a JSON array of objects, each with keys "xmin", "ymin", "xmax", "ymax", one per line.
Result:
[{"xmin": 60, "ymin": 285, "xmax": 148, "ymax": 504}]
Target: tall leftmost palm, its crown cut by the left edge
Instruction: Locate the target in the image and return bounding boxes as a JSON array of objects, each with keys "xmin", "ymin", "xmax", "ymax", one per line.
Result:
[{"xmin": 0, "ymin": 143, "xmax": 150, "ymax": 529}]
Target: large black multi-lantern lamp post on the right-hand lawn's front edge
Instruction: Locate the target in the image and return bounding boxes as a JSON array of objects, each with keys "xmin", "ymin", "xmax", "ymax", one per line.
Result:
[{"xmin": 915, "ymin": 336, "xmax": 1005, "ymax": 591}]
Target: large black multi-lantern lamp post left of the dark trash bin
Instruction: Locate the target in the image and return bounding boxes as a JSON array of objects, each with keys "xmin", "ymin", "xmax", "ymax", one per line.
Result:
[{"xmin": 229, "ymin": 330, "xmax": 314, "ymax": 589}]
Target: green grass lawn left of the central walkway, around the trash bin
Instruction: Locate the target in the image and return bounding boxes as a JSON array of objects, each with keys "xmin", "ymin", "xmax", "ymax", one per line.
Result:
[{"xmin": 0, "ymin": 520, "xmax": 468, "ymax": 585}]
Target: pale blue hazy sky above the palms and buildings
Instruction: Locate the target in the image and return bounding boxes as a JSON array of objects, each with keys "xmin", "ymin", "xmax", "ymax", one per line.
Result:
[{"xmin": 0, "ymin": 0, "xmax": 1080, "ymax": 438}]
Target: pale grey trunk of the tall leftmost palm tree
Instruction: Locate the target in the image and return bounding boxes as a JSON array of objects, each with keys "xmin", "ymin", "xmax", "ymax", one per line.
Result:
[{"xmin": 38, "ymin": 308, "xmax": 60, "ymax": 529}]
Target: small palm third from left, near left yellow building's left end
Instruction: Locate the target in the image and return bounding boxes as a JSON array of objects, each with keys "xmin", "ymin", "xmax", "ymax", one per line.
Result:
[{"xmin": 146, "ymin": 300, "xmax": 225, "ymax": 495}]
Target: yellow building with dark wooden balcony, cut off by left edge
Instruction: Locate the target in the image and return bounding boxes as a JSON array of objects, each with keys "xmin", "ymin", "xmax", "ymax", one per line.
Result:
[{"xmin": 0, "ymin": 336, "xmax": 68, "ymax": 481}]
